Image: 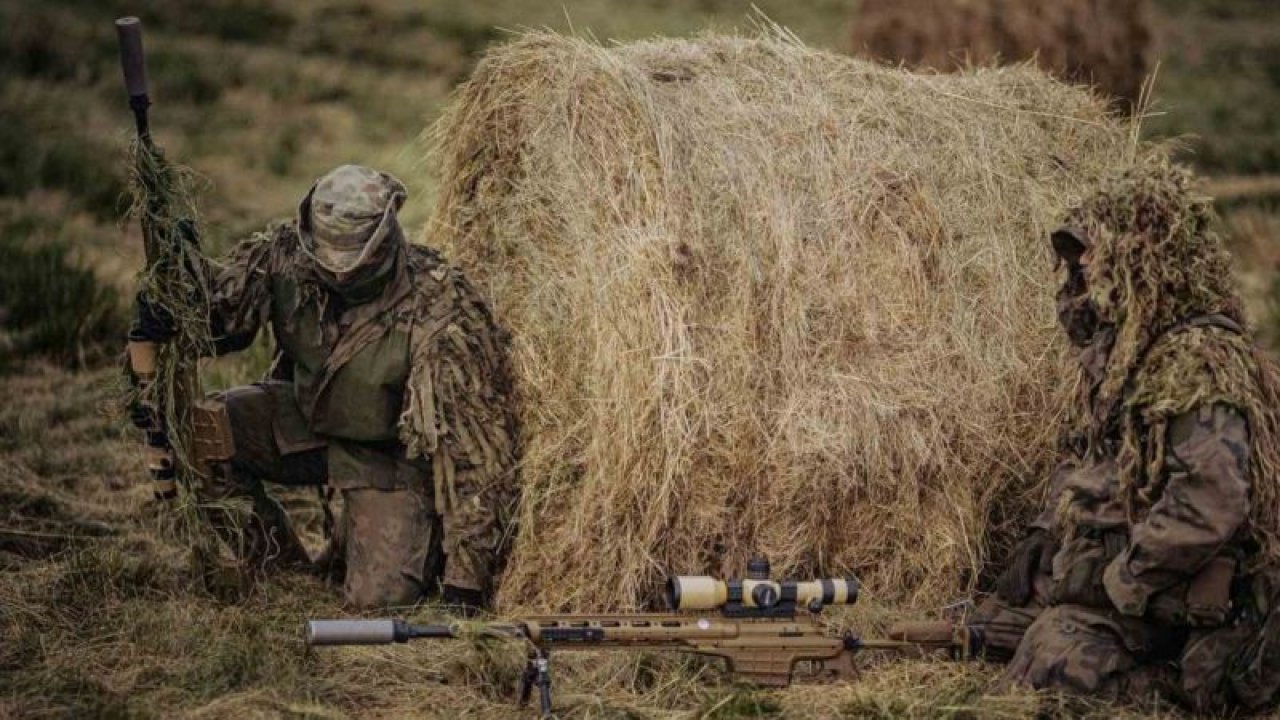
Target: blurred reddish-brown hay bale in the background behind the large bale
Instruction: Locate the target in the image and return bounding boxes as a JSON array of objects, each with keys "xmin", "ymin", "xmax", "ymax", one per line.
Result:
[{"xmin": 851, "ymin": 0, "xmax": 1152, "ymax": 109}]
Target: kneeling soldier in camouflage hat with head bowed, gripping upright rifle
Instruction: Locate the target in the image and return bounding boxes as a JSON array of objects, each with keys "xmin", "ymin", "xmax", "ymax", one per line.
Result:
[{"xmin": 140, "ymin": 165, "xmax": 516, "ymax": 609}]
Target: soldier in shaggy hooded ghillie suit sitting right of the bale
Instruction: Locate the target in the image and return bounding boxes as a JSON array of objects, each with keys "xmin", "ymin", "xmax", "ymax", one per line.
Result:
[{"xmin": 973, "ymin": 167, "xmax": 1280, "ymax": 711}]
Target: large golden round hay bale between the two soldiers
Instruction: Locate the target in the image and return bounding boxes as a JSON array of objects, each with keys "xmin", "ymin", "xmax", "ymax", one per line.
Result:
[{"xmin": 424, "ymin": 33, "xmax": 1144, "ymax": 610}]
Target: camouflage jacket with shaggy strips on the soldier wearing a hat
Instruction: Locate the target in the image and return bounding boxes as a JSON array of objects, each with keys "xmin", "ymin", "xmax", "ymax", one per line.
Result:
[{"xmin": 204, "ymin": 223, "xmax": 516, "ymax": 589}]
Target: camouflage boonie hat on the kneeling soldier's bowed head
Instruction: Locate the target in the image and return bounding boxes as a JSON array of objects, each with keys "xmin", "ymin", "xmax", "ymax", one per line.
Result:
[{"xmin": 298, "ymin": 165, "xmax": 408, "ymax": 273}]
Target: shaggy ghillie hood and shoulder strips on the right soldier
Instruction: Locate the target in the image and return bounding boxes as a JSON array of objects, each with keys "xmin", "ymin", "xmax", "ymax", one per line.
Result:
[{"xmin": 1068, "ymin": 165, "xmax": 1280, "ymax": 566}]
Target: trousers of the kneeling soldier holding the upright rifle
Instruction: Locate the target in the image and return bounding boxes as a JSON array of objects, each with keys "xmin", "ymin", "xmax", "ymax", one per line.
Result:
[{"xmin": 205, "ymin": 383, "xmax": 443, "ymax": 609}]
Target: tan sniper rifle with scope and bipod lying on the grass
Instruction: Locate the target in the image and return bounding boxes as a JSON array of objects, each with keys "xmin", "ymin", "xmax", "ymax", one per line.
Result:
[{"xmin": 306, "ymin": 559, "xmax": 982, "ymax": 717}]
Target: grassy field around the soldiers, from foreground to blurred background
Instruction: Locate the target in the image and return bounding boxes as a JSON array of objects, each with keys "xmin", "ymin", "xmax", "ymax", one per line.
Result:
[{"xmin": 0, "ymin": 0, "xmax": 1280, "ymax": 717}]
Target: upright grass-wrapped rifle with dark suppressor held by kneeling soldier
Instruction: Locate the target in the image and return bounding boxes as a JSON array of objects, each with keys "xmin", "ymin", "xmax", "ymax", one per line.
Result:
[{"xmin": 115, "ymin": 18, "xmax": 216, "ymax": 500}]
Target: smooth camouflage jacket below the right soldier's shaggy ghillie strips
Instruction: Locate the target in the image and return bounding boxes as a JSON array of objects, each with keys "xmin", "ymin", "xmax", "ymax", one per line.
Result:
[{"xmin": 1036, "ymin": 327, "xmax": 1256, "ymax": 625}]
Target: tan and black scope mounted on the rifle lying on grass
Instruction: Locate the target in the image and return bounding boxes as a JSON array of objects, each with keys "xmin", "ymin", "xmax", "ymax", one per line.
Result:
[{"xmin": 667, "ymin": 559, "xmax": 859, "ymax": 615}]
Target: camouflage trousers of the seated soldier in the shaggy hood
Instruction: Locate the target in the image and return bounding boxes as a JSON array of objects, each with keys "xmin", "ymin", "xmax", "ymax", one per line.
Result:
[{"xmin": 972, "ymin": 597, "xmax": 1280, "ymax": 712}]
